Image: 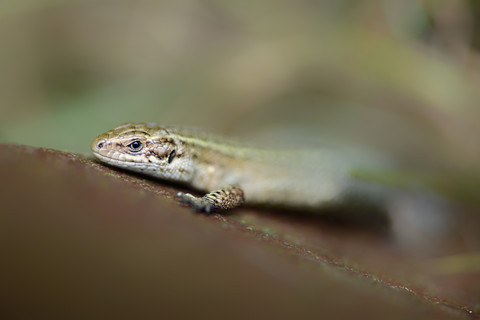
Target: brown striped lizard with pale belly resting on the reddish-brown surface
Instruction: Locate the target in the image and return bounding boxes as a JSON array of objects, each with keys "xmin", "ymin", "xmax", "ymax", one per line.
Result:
[{"xmin": 91, "ymin": 123, "xmax": 394, "ymax": 213}]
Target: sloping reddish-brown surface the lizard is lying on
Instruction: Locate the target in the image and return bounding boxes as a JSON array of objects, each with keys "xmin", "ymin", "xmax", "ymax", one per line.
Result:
[{"xmin": 0, "ymin": 145, "xmax": 480, "ymax": 319}]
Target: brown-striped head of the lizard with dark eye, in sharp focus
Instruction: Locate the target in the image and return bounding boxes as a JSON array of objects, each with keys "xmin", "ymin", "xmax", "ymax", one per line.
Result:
[{"xmin": 91, "ymin": 123, "xmax": 193, "ymax": 182}]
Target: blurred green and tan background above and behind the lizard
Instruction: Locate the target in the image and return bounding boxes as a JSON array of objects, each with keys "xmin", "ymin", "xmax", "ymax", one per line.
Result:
[{"xmin": 0, "ymin": 0, "xmax": 480, "ymax": 173}]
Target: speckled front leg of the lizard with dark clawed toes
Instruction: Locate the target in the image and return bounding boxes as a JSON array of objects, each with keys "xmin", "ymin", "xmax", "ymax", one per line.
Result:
[{"xmin": 176, "ymin": 185, "xmax": 245, "ymax": 213}]
